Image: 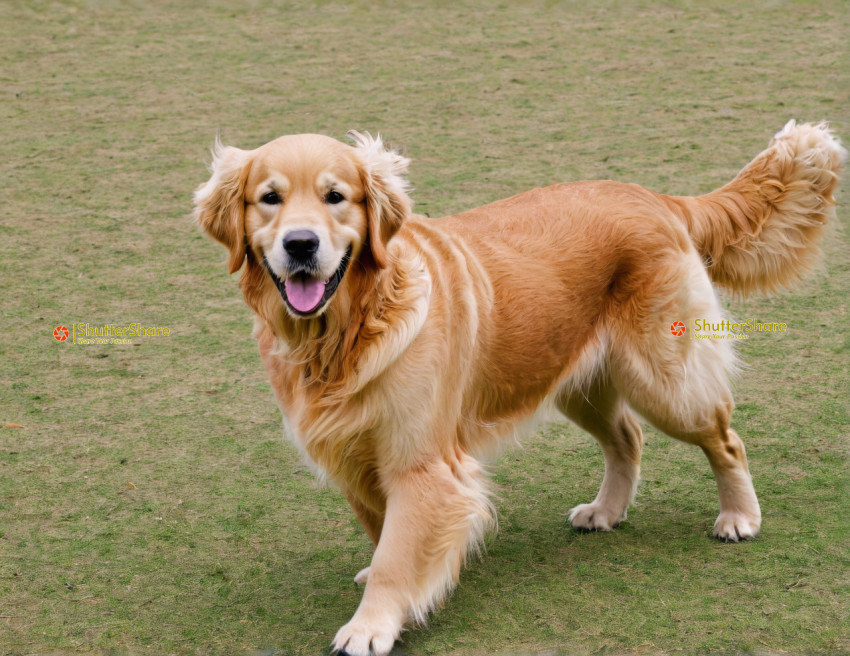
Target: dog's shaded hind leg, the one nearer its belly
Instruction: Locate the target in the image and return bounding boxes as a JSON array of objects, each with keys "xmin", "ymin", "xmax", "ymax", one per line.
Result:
[{"xmin": 556, "ymin": 374, "xmax": 643, "ymax": 531}]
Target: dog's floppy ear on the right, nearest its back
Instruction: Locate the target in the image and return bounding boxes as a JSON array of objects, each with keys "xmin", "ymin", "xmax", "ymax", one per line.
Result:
[{"xmin": 348, "ymin": 130, "xmax": 411, "ymax": 268}]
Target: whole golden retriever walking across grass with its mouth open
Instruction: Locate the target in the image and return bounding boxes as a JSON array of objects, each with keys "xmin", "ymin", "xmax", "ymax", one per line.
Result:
[{"xmin": 194, "ymin": 120, "xmax": 847, "ymax": 656}]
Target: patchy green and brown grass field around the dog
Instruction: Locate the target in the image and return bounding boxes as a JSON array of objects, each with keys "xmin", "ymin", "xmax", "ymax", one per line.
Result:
[{"xmin": 0, "ymin": 0, "xmax": 850, "ymax": 656}]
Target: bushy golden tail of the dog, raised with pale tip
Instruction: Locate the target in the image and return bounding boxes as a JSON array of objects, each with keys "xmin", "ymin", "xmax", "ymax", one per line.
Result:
[{"xmin": 664, "ymin": 120, "xmax": 847, "ymax": 296}]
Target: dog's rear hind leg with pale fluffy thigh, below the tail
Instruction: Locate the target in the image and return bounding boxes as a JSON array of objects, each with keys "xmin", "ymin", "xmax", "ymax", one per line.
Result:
[{"xmin": 609, "ymin": 263, "xmax": 761, "ymax": 542}]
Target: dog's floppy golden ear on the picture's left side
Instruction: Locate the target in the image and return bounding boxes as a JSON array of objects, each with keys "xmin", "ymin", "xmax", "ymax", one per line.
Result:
[{"xmin": 193, "ymin": 139, "xmax": 251, "ymax": 273}]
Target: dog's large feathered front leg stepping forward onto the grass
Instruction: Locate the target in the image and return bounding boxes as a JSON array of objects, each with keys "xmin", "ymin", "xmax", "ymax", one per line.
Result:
[{"xmin": 333, "ymin": 456, "xmax": 494, "ymax": 656}]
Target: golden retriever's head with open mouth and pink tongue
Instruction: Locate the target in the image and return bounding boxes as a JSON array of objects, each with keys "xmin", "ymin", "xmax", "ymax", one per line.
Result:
[{"xmin": 194, "ymin": 131, "xmax": 410, "ymax": 318}]
